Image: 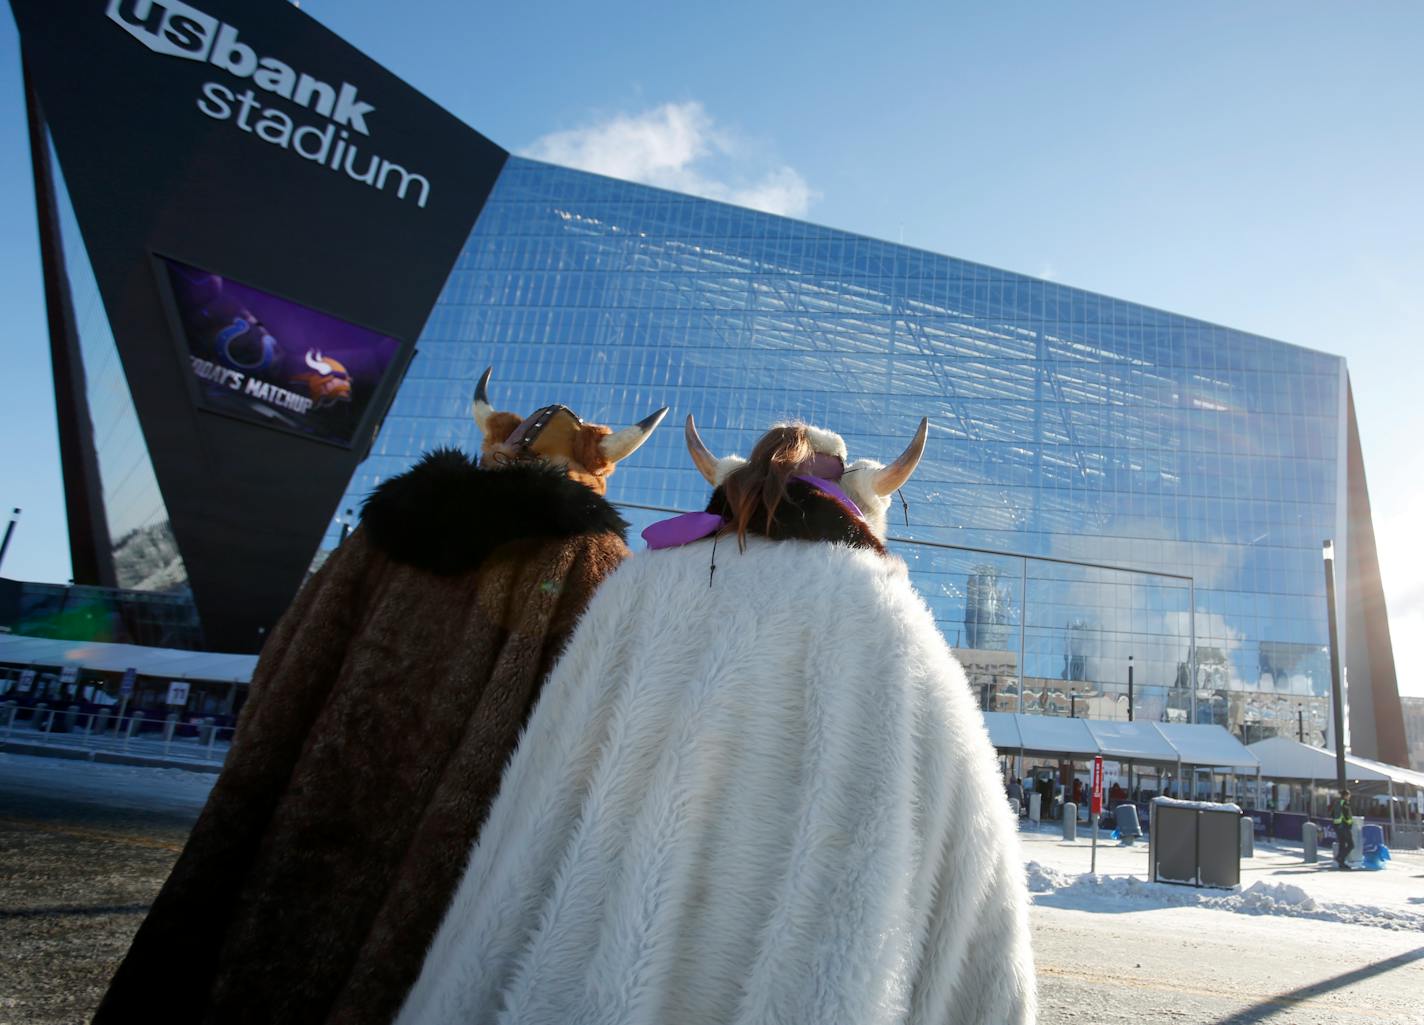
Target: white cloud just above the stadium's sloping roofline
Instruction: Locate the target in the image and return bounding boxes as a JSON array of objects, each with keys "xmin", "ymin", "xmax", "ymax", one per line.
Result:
[{"xmin": 523, "ymin": 101, "xmax": 816, "ymax": 218}]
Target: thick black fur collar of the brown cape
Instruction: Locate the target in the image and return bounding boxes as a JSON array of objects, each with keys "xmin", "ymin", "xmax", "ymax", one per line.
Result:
[{"xmin": 362, "ymin": 448, "xmax": 628, "ymax": 575}]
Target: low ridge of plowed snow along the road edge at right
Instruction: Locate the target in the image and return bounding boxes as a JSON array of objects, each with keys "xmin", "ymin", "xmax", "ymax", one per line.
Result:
[{"xmin": 1025, "ymin": 861, "xmax": 1424, "ymax": 932}]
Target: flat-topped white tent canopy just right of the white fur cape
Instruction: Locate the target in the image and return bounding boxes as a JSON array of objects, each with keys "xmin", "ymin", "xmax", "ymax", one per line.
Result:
[{"xmin": 983, "ymin": 712, "xmax": 1259, "ymax": 774}]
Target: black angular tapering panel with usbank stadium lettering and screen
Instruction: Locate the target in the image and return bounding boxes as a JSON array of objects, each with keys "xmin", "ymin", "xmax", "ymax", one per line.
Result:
[{"xmin": 11, "ymin": 0, "xmax": 507, "ymax": 651}]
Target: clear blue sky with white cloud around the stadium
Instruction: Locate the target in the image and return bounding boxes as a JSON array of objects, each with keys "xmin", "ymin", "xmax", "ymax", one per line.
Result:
[{"xmin": 0, "ymin": 0, "xmax": 1424, "ymax": 695}]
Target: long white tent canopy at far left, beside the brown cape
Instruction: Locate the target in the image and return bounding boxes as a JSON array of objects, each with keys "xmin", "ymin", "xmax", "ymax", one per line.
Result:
[{"xmin": 0, "ymin": 634, "xmax": 258, "ymax": 683}]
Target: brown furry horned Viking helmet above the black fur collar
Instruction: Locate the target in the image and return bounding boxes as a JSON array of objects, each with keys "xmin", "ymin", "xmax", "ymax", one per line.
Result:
[{"xmin": 473, "ymin": 367, "xmax": 668, "ymax": 494}]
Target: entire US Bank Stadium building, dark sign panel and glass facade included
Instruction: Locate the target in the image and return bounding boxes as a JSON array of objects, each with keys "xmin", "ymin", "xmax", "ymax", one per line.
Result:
[{"xmin": 0, "ymin": 0, "xmax": 1407, "ymax": 808}]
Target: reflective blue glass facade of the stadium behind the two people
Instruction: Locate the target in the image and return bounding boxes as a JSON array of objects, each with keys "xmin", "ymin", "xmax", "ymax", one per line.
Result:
[{"xmin": 323, "ymin": 158, "xmax": 1349, "ymax": 743}]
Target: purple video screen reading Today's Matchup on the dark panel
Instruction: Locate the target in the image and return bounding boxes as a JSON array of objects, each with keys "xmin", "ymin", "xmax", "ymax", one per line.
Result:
[{"xmin": 158, "ymin": 256, "xmax": 400, "ymax": 446}]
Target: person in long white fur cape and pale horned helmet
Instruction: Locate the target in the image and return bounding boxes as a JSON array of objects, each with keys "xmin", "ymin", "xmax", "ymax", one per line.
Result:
[{"xmin": 397, "ymin": 417, "xmax": 1037, "ymax": 1025}]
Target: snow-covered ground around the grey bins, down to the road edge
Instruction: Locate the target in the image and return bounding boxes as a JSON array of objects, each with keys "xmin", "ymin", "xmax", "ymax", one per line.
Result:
[{"xmin": 1020, "ymin": 823, "xmax": 1424, "ymax": 932}]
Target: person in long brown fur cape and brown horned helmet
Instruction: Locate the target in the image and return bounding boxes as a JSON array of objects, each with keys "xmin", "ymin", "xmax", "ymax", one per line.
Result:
[{"xmin": 94, "ymin": 370, "xmax": 666, "ymax": 1025}]
